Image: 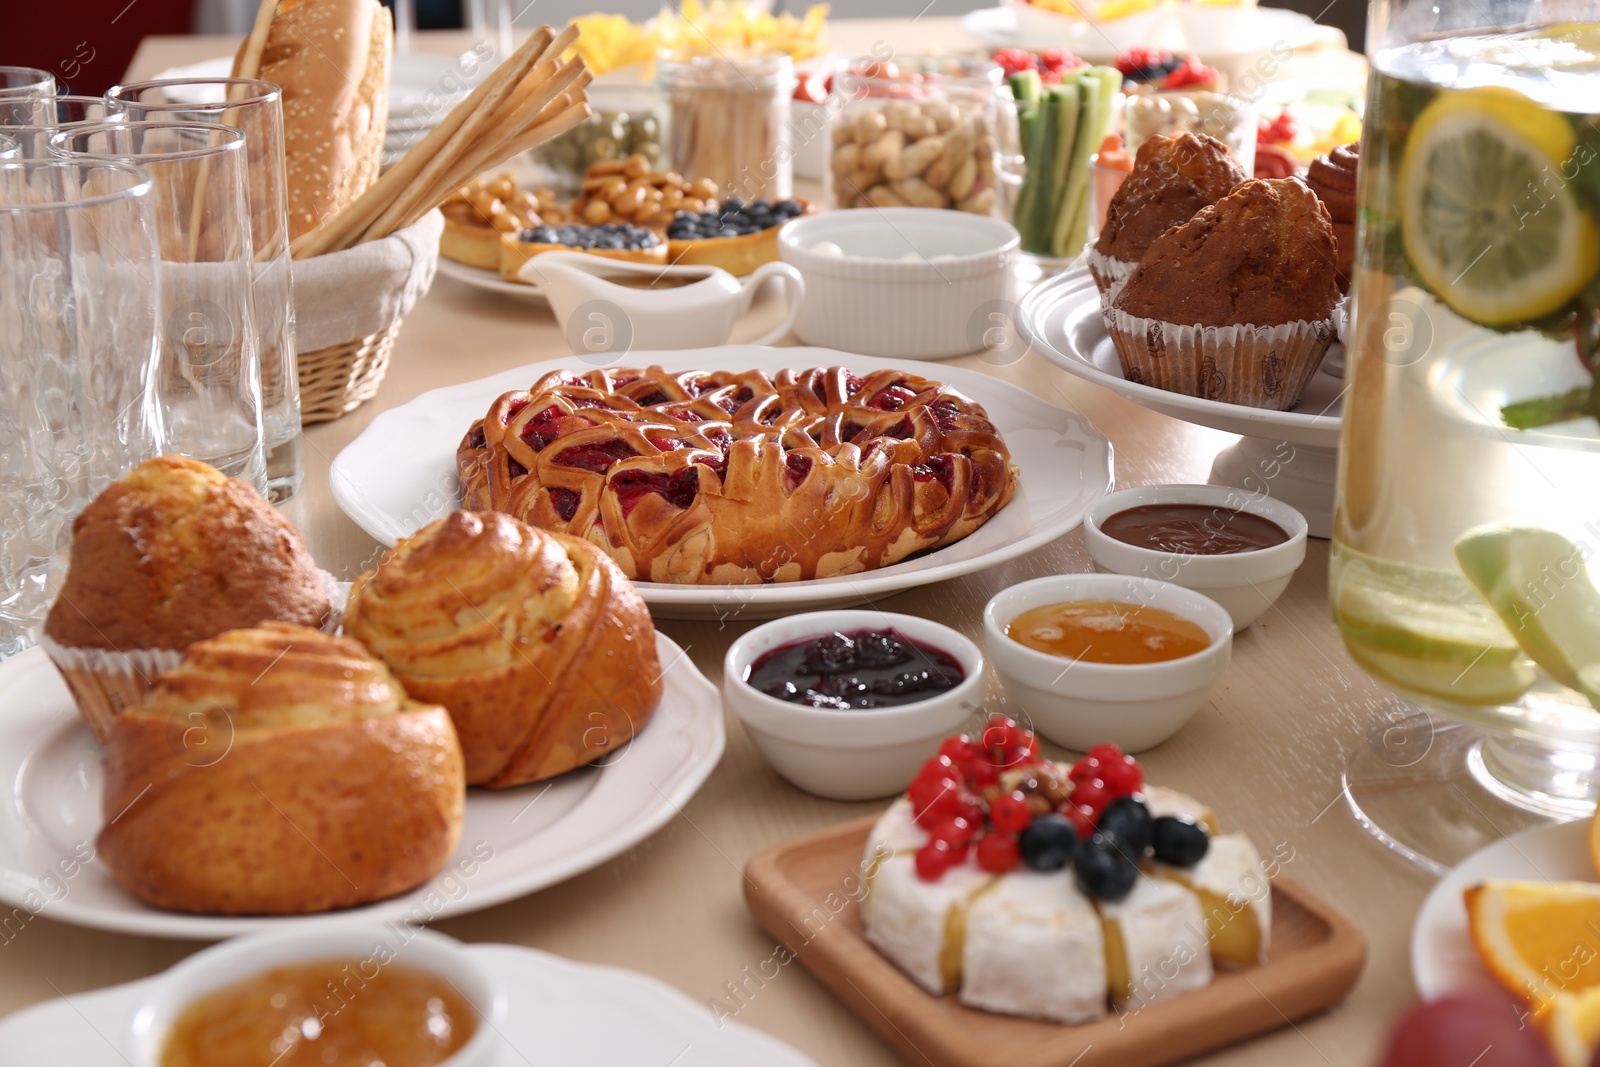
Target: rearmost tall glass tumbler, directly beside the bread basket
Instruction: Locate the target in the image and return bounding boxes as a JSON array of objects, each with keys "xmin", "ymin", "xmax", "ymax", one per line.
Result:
[{"xmin": 106, "ymin": 78, "xmax": 304, "ymax": 504}]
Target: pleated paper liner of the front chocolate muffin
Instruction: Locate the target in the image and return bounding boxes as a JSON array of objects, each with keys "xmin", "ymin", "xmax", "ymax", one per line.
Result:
[{"xmin": 1106, "ymin": 307, "xmax": 1334, "ymax": 411}]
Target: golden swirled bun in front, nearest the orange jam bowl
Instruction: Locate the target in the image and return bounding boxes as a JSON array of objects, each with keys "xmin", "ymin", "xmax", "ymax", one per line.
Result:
[{"xmin": 98, "ymin": 622, "xmax": 466, "ymax": 915}]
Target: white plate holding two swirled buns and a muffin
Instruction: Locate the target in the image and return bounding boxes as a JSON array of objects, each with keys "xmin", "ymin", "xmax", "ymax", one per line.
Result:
[{"xmin": 0, "ymin": 633, "xmax": 725, "ymax": 940}]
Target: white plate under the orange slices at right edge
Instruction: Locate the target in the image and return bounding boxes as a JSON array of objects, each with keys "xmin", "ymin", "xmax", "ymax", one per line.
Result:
[{"xmin": 1411, "ymin": 819, "xmax": 1595, "ymax": 1013}]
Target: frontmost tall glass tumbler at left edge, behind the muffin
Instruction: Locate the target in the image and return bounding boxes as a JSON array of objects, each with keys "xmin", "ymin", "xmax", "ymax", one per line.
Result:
[{"xmin": 0, "ymin": 160, "xmax": 163, "ymax": 657}]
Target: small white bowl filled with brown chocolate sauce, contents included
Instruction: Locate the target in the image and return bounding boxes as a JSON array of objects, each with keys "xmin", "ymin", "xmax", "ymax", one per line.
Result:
[{"xmin": 1083, "ymin": 485, "xmax": 1309, "ymax": 633}]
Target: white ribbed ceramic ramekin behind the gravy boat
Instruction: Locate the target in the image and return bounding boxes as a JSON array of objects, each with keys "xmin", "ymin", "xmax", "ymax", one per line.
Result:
[{"xmin": 778, "ymin": 208, "xmax": 1021, "ymax": 360}]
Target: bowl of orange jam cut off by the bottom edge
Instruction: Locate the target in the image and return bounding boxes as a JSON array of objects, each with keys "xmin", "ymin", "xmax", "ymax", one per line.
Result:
[{"xmin": 126, "ymin": 921, "xmax": 507, "ymax": 1067}]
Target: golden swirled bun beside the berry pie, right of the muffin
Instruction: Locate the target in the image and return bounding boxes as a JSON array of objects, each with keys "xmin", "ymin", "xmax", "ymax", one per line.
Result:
[{"xmin": 344, "ymin": 512, "xmax": 661, "ymax": 787}]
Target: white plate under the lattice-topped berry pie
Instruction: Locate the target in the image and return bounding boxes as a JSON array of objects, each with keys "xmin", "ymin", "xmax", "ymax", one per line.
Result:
[{"xmin": 328, "ymin": 344, "xmax": 1112, "ymax": 619}]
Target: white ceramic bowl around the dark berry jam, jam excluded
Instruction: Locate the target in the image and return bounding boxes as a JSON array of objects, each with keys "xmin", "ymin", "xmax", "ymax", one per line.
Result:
[{"xmin": 722, "ymin": 611, "xmax": 984, "ymax": 800}]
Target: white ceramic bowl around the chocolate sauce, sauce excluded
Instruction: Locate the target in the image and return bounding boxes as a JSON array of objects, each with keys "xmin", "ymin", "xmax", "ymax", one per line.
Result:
[{"xmin": 1083, "ymin": 485, "xmax": 1307, "ymax": 633}]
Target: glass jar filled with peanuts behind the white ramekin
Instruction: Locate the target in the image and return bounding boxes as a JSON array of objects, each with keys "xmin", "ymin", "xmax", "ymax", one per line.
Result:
[{"xmin": 827, "ymin": 56, "xmax": 1021, "ymax": 218}]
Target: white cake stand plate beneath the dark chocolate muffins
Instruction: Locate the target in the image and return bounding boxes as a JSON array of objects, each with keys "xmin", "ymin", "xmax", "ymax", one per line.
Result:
[{"xmin": 1016, "ymin": 267, "xmax": 1344, "ymax": 448}]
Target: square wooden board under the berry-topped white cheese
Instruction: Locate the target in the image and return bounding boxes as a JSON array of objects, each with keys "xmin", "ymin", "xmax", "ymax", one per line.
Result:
[{"xmin": 744, "ymin": 817, "xmax": 1366, "ymax": 1067}]
